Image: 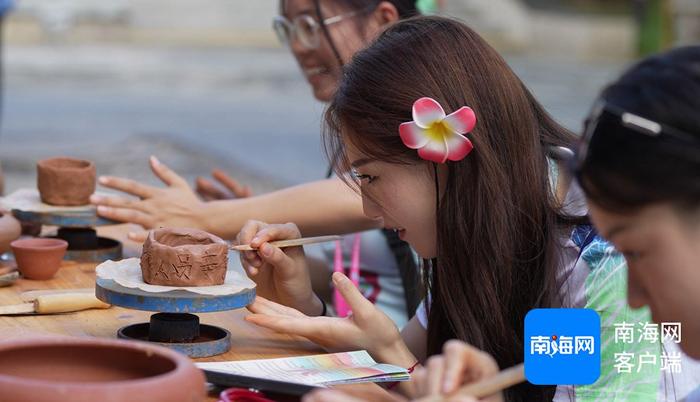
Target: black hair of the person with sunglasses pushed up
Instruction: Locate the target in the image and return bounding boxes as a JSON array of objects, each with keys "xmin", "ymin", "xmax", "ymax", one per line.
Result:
[{"xmin": 577, "ymin": 46, "xmax": 700, "ymax": 211}]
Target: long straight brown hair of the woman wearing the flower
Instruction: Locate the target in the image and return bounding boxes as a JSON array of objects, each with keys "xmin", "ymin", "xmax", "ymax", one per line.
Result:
[{"xmin": 324, "ymin": 17, "xmax": 575, "ymax": 401}]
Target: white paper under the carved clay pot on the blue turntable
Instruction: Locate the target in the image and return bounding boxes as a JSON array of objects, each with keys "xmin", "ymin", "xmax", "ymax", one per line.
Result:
[{"xmin": 96, "ymin": 254, "xmax": 255, "ymax": 296}]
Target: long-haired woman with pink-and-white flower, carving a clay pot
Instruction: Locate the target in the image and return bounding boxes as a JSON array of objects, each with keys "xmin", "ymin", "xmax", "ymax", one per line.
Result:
[{"xmin": 239, "ymin": 17, "xmax": 700, "ymax": 401}]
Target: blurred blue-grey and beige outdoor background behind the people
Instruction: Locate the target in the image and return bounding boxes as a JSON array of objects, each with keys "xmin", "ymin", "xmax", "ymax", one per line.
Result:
[{"xmin": 0, "ymin": 0, "xmax": 700, "ymax": 193}]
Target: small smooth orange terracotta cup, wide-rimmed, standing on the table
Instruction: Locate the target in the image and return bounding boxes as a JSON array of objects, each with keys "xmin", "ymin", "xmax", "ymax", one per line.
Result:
[{"xmin": 10, "ymin": 238, "xmax": 68, "ymax": 281}]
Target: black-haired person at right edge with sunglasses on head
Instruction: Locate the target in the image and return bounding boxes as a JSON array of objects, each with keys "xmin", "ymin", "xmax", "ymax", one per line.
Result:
[{"xmin": 573, "ymin": 46, "xmax": 700, "ymax": 401}]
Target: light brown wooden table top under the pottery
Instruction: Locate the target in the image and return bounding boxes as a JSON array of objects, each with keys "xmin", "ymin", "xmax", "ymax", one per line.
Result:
[{"xmin": 0, "ymin": 225, "xmax": 323, "ymax": 401}]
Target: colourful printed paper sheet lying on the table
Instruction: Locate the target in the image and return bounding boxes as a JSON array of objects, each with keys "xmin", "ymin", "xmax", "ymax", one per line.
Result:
[{"xmin": 195, "ymin": 350, "xmax": 410, "ymax": 386}]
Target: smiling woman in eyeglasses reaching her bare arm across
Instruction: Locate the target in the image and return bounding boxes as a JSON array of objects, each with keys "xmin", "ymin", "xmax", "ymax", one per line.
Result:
[{"xmin": 92, "ymin": 0, "xmax": 420, "ymax": 326}]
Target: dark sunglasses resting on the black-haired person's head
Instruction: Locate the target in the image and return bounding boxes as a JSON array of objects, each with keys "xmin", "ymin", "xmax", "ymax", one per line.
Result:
[{"xmin": 574, "ymin": 100, "xmax": 698, "ymax": 172}]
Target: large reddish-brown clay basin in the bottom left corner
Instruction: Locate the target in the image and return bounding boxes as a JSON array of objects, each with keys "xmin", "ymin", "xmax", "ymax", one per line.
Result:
[{"xmin": 0, "ymin": 337, "xmax": 205, "ymax": 402}]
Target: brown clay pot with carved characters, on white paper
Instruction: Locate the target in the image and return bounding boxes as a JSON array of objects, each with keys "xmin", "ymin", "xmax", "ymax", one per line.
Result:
[{"xmin": 141, "ymin": 228, "xmax": 228, "ymax": 286}]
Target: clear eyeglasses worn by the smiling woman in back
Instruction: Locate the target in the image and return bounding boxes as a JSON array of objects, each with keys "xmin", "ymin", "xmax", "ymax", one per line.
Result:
[{"xmin": 272, "ymin": 10, "xmax": 364, "ymax": 49}]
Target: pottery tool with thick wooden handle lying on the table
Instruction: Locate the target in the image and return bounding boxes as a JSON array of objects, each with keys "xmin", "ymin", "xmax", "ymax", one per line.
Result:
[{"xmin": 0, "ymin": 292, "xmax": 110, "ymax": 315}]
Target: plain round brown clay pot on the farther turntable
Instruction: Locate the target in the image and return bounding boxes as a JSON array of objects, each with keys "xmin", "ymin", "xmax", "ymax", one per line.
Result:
[{"xmin": 36, "ymin": 158, "xmax": 95, "ymax": 206}]
